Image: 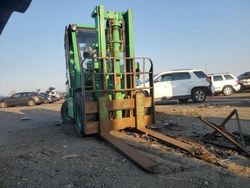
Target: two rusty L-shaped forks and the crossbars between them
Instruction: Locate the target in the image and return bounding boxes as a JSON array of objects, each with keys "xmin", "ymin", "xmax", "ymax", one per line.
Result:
[{"xmin": 91, "ymin": 92, "xmax": 219, "ymax": 172}]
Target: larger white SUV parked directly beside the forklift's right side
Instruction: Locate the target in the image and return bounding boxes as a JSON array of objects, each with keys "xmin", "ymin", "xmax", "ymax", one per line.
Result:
[{"xmin": 138, "ymin": 69, "xmax": 211, "ymax": 103}]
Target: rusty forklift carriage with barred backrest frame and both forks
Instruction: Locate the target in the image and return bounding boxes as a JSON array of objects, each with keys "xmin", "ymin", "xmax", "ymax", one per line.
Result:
[{"xmin": 82, "ymin": 58, "xmax": 223, "ymax": 172}]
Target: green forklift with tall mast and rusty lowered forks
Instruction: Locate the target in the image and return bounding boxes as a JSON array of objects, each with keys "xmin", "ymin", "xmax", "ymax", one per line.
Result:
[{"xmin": 61, "ymin": 6, "xmax": 215, "ymax": 172}]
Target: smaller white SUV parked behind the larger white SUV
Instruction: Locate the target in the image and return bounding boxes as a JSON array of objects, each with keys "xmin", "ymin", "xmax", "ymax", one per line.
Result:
[{"xmin": 208, "ymin": 73, "xmax": 240, "ymax": 96}]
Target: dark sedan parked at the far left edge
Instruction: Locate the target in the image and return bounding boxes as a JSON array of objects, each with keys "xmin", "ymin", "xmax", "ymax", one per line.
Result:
[{"xmin": 0, "ymin": 92, "xmax": 44, "ymax": 108}]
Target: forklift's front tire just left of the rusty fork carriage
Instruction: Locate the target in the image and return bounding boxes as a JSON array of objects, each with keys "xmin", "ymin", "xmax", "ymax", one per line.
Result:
[{"xmin": 75, "ymin": 92, "xmax": 85, "ymax": 137}]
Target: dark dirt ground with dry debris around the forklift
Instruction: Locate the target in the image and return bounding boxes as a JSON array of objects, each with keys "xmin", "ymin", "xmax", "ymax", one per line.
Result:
[{"xmin": 0, "ymin": 95, "xmax": 250, "ymax": 188}]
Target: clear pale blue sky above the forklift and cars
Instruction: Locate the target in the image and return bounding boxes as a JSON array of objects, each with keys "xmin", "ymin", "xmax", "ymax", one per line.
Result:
[{"xmin": 0, "ymin": 0, "xmax": 250, "ymax": 95}]
